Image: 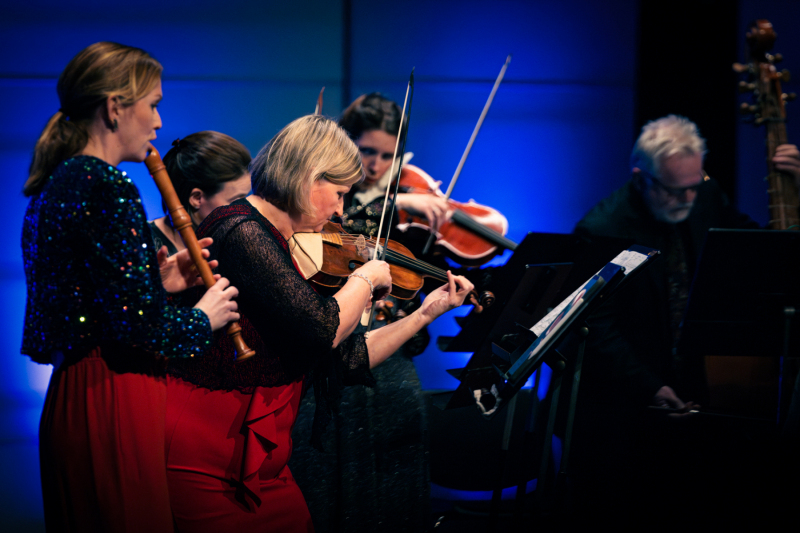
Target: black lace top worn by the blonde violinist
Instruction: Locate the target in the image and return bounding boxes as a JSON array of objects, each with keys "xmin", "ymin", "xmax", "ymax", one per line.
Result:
[{"xmin": 168, "ymin": 199, "xmax": 372, "ymax": 410}]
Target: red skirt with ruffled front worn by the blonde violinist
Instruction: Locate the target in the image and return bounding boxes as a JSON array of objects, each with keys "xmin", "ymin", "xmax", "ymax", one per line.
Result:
[{"xmin": 166, "ymin": 377, "xmax": 314, "ymax": 533}]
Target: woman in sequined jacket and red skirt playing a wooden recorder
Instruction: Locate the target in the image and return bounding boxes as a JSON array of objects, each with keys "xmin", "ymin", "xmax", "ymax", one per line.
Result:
[{"xmin": 21, "ymin": 42, "xmax": 238, "ymax": 533}]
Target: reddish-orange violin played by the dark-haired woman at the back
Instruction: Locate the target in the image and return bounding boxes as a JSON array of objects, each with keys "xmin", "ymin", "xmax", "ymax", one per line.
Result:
[{"xmin": 398, "ymin": 165, "xmax": 517, "ymax": 267}]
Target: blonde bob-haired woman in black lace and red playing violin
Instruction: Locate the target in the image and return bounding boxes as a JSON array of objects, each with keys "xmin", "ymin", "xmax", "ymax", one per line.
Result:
[{"xmin": 167, "ymin": 116, "xmax": 472, "ymax": 532}]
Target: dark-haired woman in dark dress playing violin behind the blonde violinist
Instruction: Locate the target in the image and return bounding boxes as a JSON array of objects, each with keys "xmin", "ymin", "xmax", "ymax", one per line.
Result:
[{"xmin": 290, "ymin": 93, "xmax": 462, "ymax": 532}]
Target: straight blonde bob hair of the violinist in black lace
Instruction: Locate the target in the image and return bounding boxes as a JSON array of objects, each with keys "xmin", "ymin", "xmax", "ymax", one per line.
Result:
[{"xmin": 250, "ymin": 115, "xmax": 364, "ymax": 215}]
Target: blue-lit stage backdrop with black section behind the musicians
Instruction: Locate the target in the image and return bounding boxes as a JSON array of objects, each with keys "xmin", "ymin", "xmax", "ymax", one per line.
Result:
[{"xmin": 0, "ymin": 0, "xmax": 800, "ymax": 531}]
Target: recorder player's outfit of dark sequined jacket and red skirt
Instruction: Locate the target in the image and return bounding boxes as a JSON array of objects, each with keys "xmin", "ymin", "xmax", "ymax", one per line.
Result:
[{"xmin": 21, "ymin": 156, "xmax": 211, "ymax": 533}]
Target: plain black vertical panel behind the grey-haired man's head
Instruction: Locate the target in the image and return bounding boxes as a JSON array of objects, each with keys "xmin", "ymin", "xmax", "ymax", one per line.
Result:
[{"xmin": 635, "ymin": 0, "xmax": 744, "ymax": 201}]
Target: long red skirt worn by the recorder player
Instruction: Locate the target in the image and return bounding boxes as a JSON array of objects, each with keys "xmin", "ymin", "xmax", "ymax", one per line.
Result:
[{"xmin": 39, "ymin": 348, "xmax": 174, "ymax": 533}]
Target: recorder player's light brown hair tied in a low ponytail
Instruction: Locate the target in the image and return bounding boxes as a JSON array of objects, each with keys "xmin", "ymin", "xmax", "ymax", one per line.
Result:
[{"xmin": 22, "ymin": 42, "xmax": 162, "ymax": 196}]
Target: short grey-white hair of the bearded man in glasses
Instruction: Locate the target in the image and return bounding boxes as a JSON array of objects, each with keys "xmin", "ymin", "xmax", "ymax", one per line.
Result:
[{"xmin": 631, "ymin": 115, "xmax": 706, "ymax": 176}]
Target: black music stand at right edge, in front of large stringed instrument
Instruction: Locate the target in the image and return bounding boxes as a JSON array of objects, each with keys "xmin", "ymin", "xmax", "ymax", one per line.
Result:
[{"xmin": 677, "ymin": 229, "xmax": 800, "ymax": 421}]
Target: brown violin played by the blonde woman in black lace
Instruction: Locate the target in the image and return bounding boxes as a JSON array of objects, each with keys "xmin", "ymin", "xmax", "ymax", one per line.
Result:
[{"xmin": 308, "ymin": 222, "xmax": 494, "ymax": 312}]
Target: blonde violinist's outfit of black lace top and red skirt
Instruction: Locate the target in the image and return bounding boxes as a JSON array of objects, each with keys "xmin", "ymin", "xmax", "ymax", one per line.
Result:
[{"xmin": 166, "ymin": 200, "xmax": 372, "ymax": 533}]
